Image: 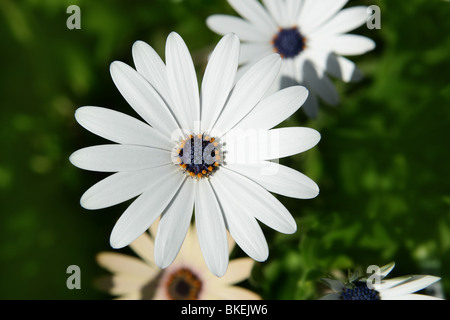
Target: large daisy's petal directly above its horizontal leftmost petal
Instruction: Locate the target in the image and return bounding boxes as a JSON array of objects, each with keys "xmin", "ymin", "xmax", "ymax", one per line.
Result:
[{"xmin": 75, "ymin": 107, "xmax": 173, "ymax": 150}]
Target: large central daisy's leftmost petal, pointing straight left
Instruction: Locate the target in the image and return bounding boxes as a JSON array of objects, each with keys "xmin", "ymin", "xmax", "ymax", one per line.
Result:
[{"xmin": 69, "ymin": 144, "xmax": 171, "ymax": 172}]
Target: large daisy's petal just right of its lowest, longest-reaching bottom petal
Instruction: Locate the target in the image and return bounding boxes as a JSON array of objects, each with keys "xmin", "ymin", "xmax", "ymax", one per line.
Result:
[{"xmin": 211, "ymin": 179, "xmax": 269, "ymax": 261}]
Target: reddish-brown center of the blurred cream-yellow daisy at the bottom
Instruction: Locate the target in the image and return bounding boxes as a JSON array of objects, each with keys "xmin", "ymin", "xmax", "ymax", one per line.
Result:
[{"xmin": 166, "ymin": 268, "xmax": 202, "ymax": 300}]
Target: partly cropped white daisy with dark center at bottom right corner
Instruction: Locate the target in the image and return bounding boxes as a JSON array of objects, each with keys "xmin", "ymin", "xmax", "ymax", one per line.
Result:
[{"xmin": 321, "ymin": 263, "xmax": 442, "ymax": 300}]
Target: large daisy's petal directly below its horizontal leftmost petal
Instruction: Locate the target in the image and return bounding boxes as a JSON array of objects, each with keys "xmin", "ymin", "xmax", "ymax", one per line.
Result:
[{"xmin": 80, "ymin": 167, "xmax": 168, "ymax": 210}]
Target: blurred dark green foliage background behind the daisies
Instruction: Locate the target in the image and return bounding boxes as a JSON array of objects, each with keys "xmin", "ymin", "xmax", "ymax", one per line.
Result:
[{"xmin": 0, "ymin": 0, "xmax": 450, "ymax": 299}]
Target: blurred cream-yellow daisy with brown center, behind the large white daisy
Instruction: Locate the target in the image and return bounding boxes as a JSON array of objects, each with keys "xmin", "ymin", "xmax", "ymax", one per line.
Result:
[{"xmin": 96, "ymin": 223, "xmax": 261, "ymax": 300}]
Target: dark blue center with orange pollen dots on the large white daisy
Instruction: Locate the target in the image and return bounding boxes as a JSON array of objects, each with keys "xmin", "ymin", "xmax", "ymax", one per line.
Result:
[{"xmin": 175, "ymin": 134, "xmax": 221, "ymax": 179}]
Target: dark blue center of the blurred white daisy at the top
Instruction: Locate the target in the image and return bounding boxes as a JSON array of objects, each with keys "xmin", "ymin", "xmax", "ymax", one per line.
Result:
[{"xmin": 272, "ymin": 27, "xmax": 305, "ymax": 58}]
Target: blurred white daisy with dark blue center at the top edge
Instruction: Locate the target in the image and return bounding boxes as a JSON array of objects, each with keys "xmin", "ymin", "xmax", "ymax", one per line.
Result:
[{"xmin": 207, "ymin": 0, "xmax": 375, "ymax": 117}]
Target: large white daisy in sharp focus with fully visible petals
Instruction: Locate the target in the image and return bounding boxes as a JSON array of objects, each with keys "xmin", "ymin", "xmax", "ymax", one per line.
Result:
[{"xmin": 70, "ymin": 33, "xmax": 320, "ymax": 276}]
